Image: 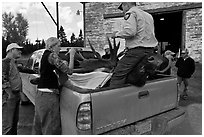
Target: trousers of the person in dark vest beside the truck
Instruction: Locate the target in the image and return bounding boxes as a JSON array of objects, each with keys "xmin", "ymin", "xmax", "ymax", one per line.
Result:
[{"xmin": 32, "ymin": 91, "xmax": 61, "ymax": 135}]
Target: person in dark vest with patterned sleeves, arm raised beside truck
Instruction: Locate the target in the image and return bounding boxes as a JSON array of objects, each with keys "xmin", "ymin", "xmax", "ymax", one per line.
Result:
[{"xmin": 32, "ymin": 37, "xmax": 75, "ymax": 135}]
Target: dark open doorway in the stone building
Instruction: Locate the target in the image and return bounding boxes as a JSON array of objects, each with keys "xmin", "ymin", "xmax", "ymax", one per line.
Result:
[{"xmin": 152, "ymin": 11, "xmax": 183, "ymax": 54}]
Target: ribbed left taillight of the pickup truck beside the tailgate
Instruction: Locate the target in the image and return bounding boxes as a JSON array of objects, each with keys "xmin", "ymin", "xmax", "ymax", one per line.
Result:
[{"xmin": 77, "ymin": 102, "xmax": 92, "ymax": 130}]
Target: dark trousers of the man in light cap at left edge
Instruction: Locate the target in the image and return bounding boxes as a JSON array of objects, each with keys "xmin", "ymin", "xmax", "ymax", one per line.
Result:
[{"xmin": 2, "ymin": 91, "xmax": 20, "ymax": 135}]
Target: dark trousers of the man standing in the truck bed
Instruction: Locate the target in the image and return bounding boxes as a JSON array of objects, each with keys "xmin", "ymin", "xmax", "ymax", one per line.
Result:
[{"xmin": 110, "ymin": 48, "xmax": 153, "ymax": 87}]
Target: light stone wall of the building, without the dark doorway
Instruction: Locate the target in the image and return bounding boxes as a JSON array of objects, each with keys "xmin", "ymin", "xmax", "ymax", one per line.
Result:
[{"xmin": 85, "ymin": 2, "xmax": 202, "ymax": 62}]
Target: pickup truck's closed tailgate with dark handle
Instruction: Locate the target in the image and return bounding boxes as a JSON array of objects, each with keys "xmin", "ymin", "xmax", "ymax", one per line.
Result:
[{"xmin": 91, "ymin": 78, "xmax": 177, "ymax": 134}]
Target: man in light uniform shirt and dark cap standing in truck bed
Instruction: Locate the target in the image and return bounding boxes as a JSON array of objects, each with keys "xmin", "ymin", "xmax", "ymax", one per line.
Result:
[{"xmin": 110, "ymin": 2, "xmax": 158, "ymax": 86}]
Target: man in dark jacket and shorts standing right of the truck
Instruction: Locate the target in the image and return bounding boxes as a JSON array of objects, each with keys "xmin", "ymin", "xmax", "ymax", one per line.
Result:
[{"xmin": 175, "ymin": 49, "xmax": 195, "ymax": 100}]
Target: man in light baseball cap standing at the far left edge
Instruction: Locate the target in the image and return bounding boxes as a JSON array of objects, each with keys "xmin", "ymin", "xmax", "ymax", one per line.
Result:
[{"xmin": 2, "ymin": 43, "xmax": 22, "ymax": 135}]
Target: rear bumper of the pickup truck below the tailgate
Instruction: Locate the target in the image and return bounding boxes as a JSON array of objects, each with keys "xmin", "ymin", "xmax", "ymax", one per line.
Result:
[{"xmin": 103, "ymin": 108, "xmax": 185, "ymax": 135}]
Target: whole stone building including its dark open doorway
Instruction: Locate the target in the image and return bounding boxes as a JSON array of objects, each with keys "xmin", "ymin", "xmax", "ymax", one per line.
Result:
[{"xmin": 84, "ymin": 2, "xmax": 202, "ymax": 62}]
